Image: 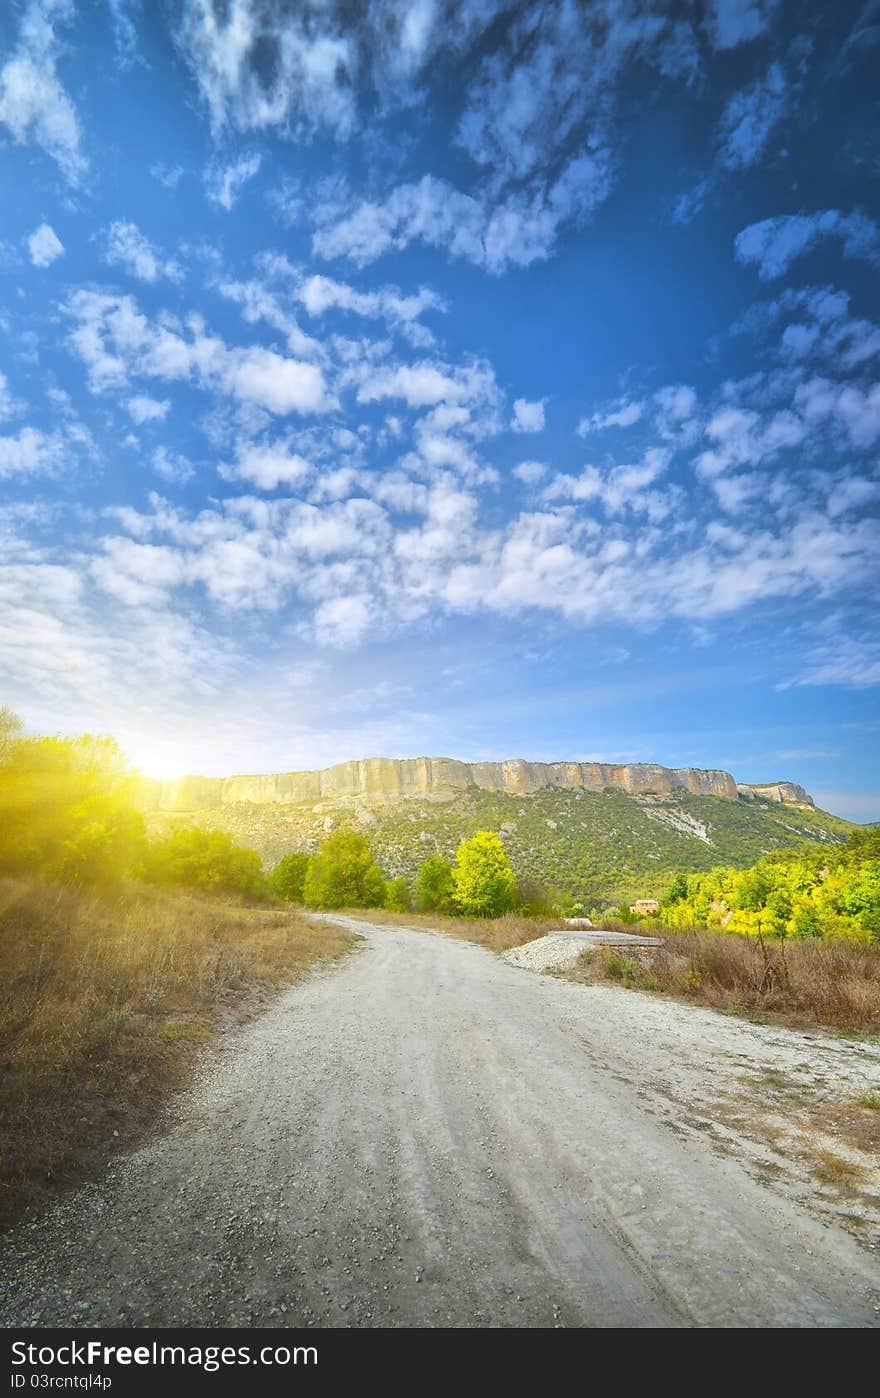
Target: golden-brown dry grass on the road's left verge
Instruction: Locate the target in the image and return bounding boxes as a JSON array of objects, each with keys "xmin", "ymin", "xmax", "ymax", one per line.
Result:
[{"xmin": 0, "ymin": 879, "xmax": 353, "ymax": 1223}]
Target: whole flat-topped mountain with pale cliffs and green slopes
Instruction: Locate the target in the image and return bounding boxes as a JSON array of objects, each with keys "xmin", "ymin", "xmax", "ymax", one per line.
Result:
[{"xmin": 143, "ymin": 758, "xmax": 852, "ymax": 906}]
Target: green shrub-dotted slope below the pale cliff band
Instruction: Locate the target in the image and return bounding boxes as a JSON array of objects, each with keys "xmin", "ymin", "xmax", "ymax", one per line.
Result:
[{"xmin": 150, "ymin": 779, "xmax": 851, "ymax": 906}]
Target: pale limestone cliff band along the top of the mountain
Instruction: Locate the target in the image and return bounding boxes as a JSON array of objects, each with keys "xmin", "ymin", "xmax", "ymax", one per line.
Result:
[{"xmin": 143, "ymin": 758, "xmax": 813, "ymax": 812}]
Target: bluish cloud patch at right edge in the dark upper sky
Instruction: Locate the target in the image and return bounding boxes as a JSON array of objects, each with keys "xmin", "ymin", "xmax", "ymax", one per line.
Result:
[{"xmin": 734, "ymin": 208, "xmax": 880, "ymax": 281}]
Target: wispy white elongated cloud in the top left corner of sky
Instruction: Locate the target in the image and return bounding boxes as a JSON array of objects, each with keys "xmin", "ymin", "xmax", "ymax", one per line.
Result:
[{"xmin": 0, "ymin": 0, "xmax": 87, "ymax": 185}]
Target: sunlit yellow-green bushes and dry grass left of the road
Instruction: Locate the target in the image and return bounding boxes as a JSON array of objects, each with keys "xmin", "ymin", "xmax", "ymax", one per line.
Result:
[{"xmin": 0, "ymin": 710, "xmax": 354, "ymax": 1225}]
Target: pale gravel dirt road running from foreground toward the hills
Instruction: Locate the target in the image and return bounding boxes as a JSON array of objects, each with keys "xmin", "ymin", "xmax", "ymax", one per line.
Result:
[{"xmin": 0, "ymin": 920, "xmax": 880, "ymax": 1327}]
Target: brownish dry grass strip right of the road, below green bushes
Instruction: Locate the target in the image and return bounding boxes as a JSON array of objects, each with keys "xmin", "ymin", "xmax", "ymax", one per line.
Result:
[{"xmin": 572, "ymin": 928, "xmax": 880, "ymax": 1033}]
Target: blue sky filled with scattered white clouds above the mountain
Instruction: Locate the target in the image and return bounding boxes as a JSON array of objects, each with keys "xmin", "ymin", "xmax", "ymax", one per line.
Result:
[{"xmin": 0, "ymin": 0, "xmax": 880, "ymax": 821}]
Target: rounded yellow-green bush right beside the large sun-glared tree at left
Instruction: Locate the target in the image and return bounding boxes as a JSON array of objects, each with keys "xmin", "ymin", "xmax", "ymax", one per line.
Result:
[{"xmin": 144, "ymin": 825, "xmax": 267, "ymax": 898}]
